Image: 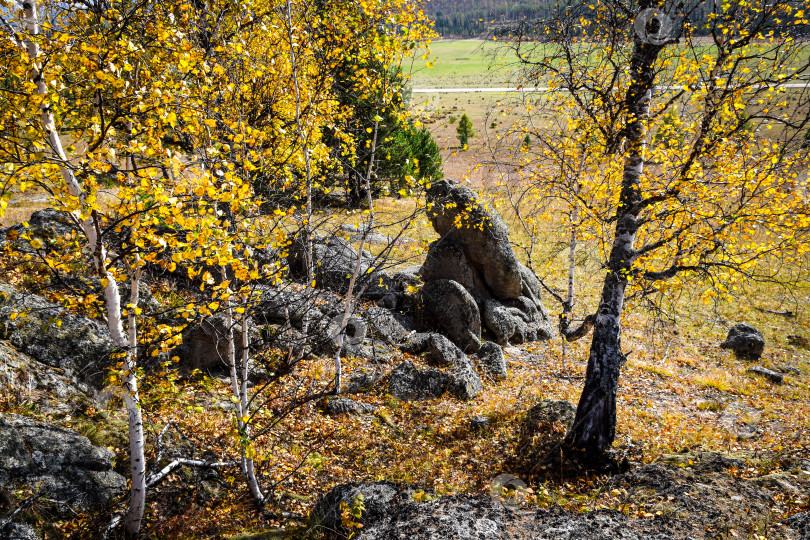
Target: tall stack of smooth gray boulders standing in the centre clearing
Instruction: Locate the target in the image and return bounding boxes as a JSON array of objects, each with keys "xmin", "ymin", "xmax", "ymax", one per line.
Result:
[{"xmin": 420, "ymin": 181, "xmax": 553, "ymax": 352}]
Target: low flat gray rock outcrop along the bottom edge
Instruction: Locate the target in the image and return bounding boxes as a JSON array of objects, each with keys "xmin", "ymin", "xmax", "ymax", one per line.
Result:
[{"xmin": 310, "ymin": 482, "xmax": 703, "ymax": 540}]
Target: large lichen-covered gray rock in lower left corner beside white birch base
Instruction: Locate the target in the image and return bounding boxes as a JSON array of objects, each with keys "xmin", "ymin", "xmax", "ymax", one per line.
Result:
[{"xmin": 0, "ymin": 414, "xmax": 127, "ymax": 517}]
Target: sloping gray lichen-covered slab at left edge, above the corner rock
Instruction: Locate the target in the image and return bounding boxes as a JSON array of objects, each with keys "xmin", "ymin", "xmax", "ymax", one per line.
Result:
[{"xmin": 0, "ymin": 282, "xmax": 114, "ymax": 386}]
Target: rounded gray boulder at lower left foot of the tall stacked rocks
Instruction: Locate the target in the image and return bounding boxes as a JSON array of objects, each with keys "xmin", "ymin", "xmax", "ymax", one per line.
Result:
[{"xmin": 422, "ymin": 279, "xmax": 481, "ymax": 352}]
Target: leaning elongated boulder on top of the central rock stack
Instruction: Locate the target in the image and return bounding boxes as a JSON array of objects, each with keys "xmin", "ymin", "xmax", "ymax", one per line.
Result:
[{"xmin": 427, "ymin": 180, "xmax": 521, "ymax": 299}]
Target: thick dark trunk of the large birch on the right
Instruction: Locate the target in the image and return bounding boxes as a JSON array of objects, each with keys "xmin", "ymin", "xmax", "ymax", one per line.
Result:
[{"xmin": 566, "ymin": 1, "xmax": 662, "ymax": 458}]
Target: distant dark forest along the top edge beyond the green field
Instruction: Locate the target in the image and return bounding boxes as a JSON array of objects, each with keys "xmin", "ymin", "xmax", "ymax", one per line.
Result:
[{"xmin": 425, "ymin": 0, "xmax": 740, "ymax": 38}]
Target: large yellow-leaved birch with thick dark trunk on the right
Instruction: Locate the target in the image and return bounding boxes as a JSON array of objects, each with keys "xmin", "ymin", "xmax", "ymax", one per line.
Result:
[{"xmin": 510, "ymin": 0, "xmax": 810, "ymax": 458}]
